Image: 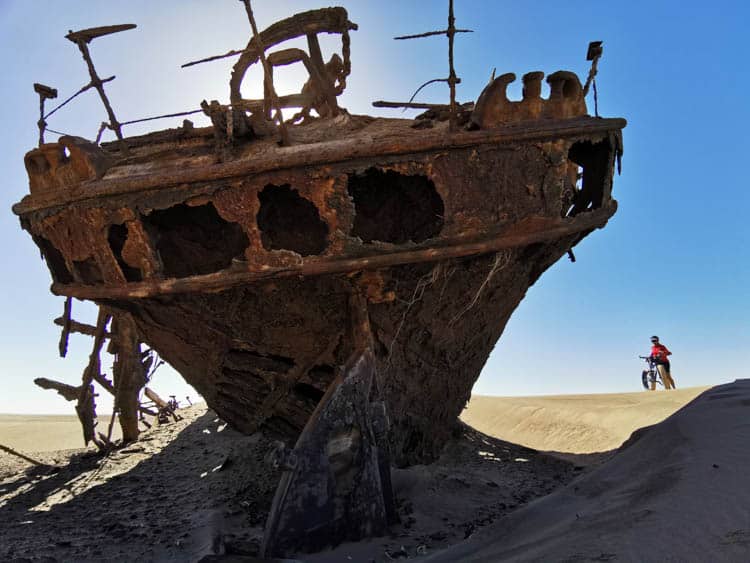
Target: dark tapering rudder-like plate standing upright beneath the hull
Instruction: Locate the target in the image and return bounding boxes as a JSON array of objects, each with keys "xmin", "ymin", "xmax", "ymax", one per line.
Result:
[{"xmin": 261, "ymin": 290, "xmax": 397, "ymax": 557}]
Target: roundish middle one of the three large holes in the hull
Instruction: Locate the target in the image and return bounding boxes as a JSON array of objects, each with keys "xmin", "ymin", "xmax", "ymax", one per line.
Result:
[{"xmin": 257, "ymin": 184, "xmax": 328, "ymax": 256}]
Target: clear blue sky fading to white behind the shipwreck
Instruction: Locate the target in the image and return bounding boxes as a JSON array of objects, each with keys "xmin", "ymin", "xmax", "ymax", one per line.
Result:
[{"xmin": 0, "ymin": 0, "xmax": 750, "ymax": 413}]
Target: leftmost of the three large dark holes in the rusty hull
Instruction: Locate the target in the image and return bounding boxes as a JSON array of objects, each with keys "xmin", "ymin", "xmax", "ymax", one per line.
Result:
[{"xmin": 143, "ymin": 203, "xmax": 250, "ymax": 278}]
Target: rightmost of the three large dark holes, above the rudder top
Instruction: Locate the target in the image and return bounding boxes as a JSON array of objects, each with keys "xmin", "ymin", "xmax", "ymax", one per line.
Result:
[{"xmin": 348, "ymin": 168, "xmax": 445, "ymax": 244}]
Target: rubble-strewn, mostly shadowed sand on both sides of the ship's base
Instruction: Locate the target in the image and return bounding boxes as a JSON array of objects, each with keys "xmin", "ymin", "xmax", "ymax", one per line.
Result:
[{"xmin": 0, "ymin": 405, "xmax": 581, "ymax": 563}]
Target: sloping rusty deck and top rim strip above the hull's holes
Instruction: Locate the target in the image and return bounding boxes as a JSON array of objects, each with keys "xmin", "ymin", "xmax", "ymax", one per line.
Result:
[{"xmin": 13, "ymin": 114, "xmax": 627, "ymax": 215}]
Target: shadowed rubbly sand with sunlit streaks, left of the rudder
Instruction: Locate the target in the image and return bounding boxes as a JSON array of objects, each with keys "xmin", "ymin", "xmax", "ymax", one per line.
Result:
[{"xmin": 0, "ymin": 411, "xmax": 278, "ymax": 561}]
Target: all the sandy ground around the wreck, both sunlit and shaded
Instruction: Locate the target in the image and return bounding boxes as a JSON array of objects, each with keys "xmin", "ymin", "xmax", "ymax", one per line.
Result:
[{"xmin": 0, "ymin": 380, "xmax": 750, "ymax": 563}]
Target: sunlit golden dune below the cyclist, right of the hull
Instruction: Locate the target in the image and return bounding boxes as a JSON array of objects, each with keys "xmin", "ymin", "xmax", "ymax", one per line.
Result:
[{"xmin": 461, "ymin": 387, "xmax": 709, "ymax": 454}]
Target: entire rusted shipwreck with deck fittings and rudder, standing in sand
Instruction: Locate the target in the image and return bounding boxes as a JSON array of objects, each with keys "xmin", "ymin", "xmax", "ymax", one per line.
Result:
[{"xmin": 13, "ymin": 0, "xmax": 626, "ymax": 556}]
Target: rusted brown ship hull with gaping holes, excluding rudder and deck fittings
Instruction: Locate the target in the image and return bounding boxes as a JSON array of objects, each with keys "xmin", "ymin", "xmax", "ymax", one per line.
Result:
[{"xmin": 15, "ymin": 115, "xmax": 624, "ymax": 463}]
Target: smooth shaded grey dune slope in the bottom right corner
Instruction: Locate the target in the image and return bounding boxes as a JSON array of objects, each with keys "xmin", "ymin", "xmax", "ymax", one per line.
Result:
[{"xmin": 428, "ymin": 379, "xmax": 750, "ymax": 562}]
